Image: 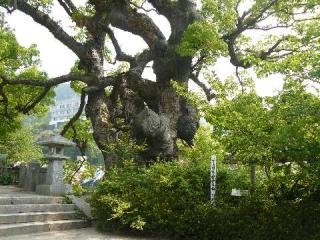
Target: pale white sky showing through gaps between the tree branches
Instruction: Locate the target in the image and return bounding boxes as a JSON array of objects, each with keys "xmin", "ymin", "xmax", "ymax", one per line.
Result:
[{"xmin": 6, "ymin": 1, "xmax": 283, "ymax": 96}]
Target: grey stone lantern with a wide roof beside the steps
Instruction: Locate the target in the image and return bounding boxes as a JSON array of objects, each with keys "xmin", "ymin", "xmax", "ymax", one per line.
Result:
[{"xmin": 36, "ymin": 132, "xmax": 75, "ymax": 195}]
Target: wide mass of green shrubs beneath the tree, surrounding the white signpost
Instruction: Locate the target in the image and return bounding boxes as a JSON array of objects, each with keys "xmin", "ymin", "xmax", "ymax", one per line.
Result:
[{"xmin": 91, "ymin": 126, "xmax": 320, "ymax": 240}]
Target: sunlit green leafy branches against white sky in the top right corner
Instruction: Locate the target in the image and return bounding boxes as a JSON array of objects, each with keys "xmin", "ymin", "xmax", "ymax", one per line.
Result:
[{"xmin": 178, "ymin": 0, "xmax": 319, "ymax": 79}]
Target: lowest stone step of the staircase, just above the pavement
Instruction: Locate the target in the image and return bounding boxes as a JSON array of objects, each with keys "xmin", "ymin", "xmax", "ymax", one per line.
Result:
[{"xmin": 0, "ymin": 220, "xmax": 89, "ymax": 237}]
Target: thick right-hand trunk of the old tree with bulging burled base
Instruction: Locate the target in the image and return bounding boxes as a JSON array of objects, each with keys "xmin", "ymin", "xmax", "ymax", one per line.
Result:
[{"xmin": 131, "ymin": 1, "xmax": 199, "ymax": 159}]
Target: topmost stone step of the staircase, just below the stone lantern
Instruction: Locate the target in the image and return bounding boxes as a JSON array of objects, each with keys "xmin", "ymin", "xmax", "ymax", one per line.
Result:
[{"xmin": 0, "ymin": 196, "xmax": 64, "ymax": 205}]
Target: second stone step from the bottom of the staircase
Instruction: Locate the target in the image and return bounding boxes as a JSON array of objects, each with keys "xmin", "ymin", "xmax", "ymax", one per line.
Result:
[{"xmin": 0, "ymin": 211, "xmax": 79, "ymax": 224}]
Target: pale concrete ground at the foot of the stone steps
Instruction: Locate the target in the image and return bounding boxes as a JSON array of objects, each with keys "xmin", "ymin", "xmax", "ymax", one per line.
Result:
[{"xmin": 0, "ymin": 228, "xmax": 156, "ymax": 240}]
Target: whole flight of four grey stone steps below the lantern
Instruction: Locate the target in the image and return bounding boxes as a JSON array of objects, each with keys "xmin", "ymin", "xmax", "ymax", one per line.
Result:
[{"xmin": 0, "ymin": 193, "xmax": 89, "ymax": 238}]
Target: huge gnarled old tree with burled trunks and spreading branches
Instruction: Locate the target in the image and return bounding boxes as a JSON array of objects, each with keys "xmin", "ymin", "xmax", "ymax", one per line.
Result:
[{"xmin": 0, "ymin": 0, "xmax": 319, "ymax": 168}]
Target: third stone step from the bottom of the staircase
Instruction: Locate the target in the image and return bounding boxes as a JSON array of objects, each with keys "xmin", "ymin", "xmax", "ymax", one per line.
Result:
[{"xmin": 0, "ymin": 204, "xmax": 75, "ymax": 214}]
